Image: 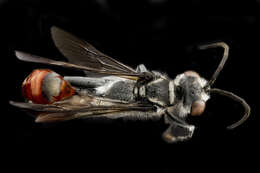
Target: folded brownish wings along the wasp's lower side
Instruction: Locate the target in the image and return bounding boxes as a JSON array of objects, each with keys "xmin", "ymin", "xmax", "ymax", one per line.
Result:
[{"xmin": 10, "ymin": 101, "xmax": 154, "ymax": 122}]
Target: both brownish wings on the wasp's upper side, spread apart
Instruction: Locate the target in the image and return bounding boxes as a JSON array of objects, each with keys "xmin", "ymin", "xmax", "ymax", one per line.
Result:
[{"xmin": 15, "ymin": 27, "xmax": 151, "ymax": 80}]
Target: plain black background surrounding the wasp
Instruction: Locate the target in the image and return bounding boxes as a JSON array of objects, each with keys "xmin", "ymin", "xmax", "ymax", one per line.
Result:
[{"xmin": 0, "ymin": 0, "xmax": 260, "ymax": 172}]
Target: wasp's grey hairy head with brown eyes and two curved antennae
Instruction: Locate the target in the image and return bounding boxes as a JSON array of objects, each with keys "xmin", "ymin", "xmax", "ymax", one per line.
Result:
[{"xmin": 171, "ymin": 42, "xmax": 250, "ymax": 129}]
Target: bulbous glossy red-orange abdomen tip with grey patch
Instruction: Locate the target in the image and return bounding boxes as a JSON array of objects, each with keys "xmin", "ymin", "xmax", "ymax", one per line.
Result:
[{"xmin": 22, "ymin": 69, "xmax": 75, "ymax": 104}]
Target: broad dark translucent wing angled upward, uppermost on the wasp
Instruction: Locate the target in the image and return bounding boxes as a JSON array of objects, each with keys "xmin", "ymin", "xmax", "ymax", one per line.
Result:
[{"xmin": 51, "ymin": 26, "xmax": 136, "ymax": 73}]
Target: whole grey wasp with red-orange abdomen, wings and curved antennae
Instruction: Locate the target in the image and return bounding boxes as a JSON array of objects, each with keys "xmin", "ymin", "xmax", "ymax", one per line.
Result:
[{"xmin": 10, "ymin": 26, "xmax": 250, "ymax": 143}]
